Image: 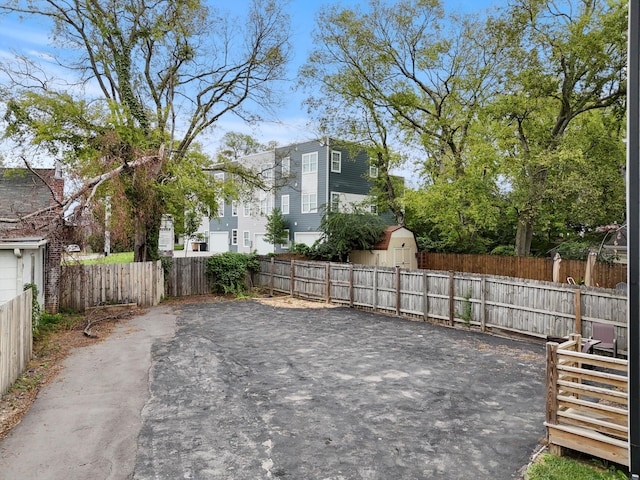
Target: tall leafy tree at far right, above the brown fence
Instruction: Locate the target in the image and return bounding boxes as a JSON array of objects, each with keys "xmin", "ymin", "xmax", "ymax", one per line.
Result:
[{"xmin": 490, "ymin": 0, "xmax": 627, "ymax": 255}]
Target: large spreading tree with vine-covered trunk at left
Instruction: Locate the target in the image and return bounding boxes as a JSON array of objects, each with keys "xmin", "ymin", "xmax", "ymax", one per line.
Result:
[{"xmin": 0, "ymin": 0, "xmax": 289, "ymax": 261}]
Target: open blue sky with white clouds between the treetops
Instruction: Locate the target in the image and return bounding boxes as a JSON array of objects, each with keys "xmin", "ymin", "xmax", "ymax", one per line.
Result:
[{"xmin": 0, "ymin": 0, "xmax": 506, "ymax": 161}]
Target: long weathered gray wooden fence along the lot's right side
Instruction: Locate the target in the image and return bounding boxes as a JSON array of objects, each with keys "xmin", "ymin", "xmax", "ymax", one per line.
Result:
[{"xmin": 256, "ymin": 258, "xmax": 627, "ymax": 348}]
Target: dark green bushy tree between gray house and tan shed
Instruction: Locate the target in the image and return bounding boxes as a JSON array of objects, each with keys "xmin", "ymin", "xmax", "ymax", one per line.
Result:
[{"xmin": 315, "ymin": 204, "xmax": 387, "ymax": 262}]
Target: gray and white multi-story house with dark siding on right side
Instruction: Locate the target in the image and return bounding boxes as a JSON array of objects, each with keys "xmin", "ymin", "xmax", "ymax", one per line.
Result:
[{"xmin": 208, "ymin": 138, "xmax": 391, "ymax": 254}]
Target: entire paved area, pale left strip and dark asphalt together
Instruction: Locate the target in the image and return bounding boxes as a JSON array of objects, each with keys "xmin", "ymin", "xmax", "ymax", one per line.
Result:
[{"xmin": 0, "ymin": 301, "xmax": 544, "ymax": 480}]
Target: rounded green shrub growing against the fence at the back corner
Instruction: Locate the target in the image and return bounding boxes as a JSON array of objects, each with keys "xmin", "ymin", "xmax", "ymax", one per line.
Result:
[{"xmin": 207, "ymin": 252, "xmax": 260, "ymax": 295}]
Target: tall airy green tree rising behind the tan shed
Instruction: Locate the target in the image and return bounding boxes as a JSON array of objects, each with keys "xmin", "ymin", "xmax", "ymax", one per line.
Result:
[{"xmin": 302, "ymin": 0, "xmax": 508, "ymax": 243}]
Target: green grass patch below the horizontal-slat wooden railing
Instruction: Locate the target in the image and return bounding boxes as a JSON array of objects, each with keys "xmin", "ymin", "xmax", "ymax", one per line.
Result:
[{"xmin": 527, "ymin": 454, "xmax": 628, "ymax": 480}]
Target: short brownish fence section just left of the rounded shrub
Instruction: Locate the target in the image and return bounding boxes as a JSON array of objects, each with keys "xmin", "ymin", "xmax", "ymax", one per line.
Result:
[{"xmin": 165, "ymin": 257, "xmax": 213, "ymax": 297}]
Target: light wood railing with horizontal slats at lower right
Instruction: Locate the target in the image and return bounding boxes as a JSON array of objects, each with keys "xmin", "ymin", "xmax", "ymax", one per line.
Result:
[{"xmin": 545, "ymin": 335, "xmax": 629, "ymax": 466}]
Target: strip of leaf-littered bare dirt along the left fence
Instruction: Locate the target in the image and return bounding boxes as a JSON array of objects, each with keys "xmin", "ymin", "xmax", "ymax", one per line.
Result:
[{"xmin": 0, "ymin": 309, "xmax": 131, "ymax": 438}]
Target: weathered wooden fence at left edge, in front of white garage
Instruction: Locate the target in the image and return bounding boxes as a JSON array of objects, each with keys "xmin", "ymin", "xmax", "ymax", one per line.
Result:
[{"xmin": 0, "ymin": 289, "xmax": 33, "ymax": 396}]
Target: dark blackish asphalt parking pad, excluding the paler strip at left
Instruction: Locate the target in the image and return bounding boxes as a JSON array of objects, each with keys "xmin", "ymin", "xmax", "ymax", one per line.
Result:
[{"xmin": 134, "ymin": 301, "xmax": 544, "ymax": 480}]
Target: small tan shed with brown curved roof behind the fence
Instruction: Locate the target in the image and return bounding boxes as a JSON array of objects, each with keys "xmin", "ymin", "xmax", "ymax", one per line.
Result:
[{"xmin": 349, "ymin": 225, "xmax": 418, "ymax": 269}]
